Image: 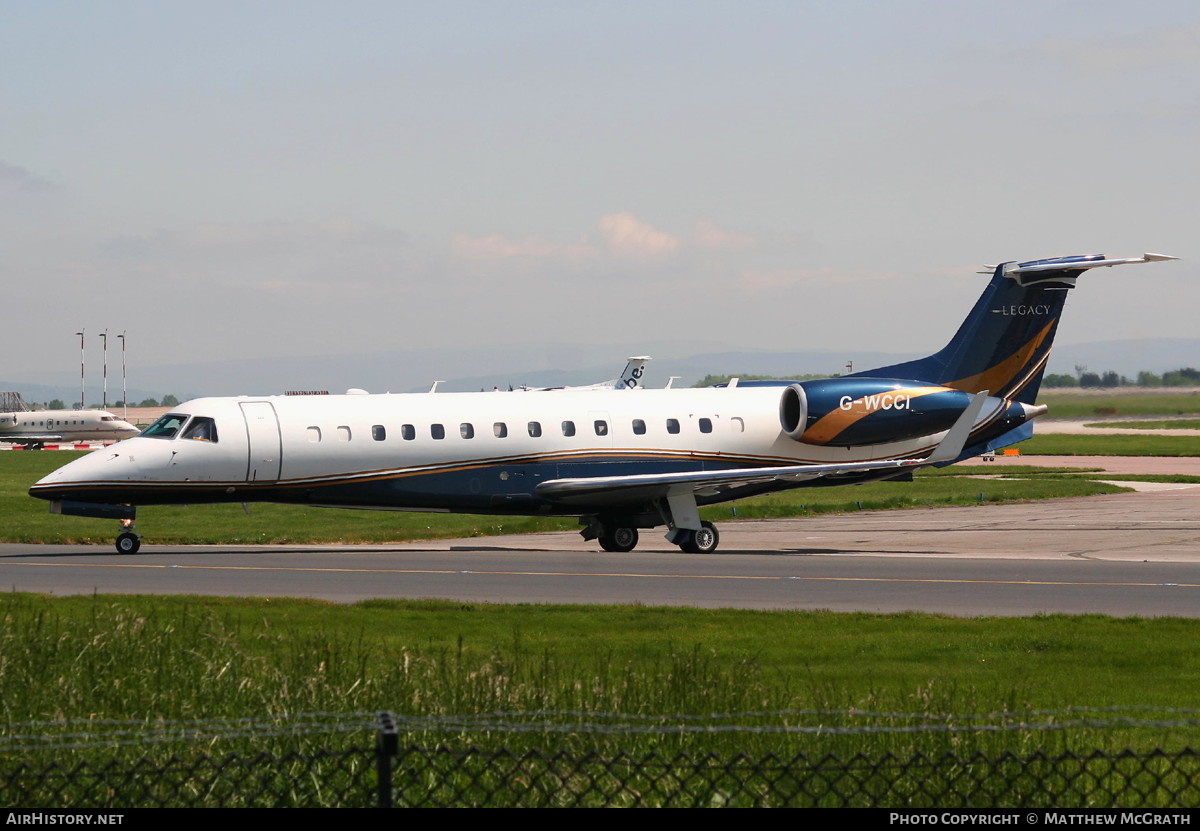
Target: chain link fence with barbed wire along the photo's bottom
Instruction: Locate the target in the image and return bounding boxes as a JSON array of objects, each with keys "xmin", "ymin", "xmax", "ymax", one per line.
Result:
[{"xmin": 7, "ymin": 713, "xmax": 1200, "ymax": 811}]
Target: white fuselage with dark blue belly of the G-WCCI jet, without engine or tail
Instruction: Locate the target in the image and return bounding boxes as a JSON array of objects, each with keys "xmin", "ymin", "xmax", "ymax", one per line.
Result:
[{"xmin": 25, "ymin": 388, "xmax": 1009, "ymax": 514}]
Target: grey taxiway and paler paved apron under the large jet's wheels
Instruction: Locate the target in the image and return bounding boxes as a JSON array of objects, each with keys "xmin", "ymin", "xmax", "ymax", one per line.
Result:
[{"xmin": 0, "ymin": 473, "xmax": 1200, "ymax": 617}]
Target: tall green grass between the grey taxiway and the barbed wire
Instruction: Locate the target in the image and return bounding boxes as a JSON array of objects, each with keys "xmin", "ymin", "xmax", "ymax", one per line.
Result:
[{"xmin": 9, "ymin": 594, "xmax": 1200, "ymax": 754}]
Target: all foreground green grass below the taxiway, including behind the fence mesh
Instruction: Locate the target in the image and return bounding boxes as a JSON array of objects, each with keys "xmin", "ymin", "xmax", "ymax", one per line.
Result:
[{"xmin": 9, "ymin": 593, "xmax": 1200, "ymax": 809}]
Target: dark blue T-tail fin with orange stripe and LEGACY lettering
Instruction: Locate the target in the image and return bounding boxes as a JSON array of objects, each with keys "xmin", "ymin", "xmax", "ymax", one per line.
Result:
[{"xmin": 854, "ymin": 253, "xmax": 1177, "ymax": 403}]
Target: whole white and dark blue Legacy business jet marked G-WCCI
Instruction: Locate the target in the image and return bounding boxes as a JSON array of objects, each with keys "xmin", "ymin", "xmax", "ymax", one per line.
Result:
[{"xmin": 30, "ymin": 253, "xmax": 1175, "ymax": 554}]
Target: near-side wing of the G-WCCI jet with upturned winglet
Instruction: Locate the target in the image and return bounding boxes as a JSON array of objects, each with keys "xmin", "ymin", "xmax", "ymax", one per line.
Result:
[{"xmin": 536, "ymin": 390, "xmax": 988, "ymax": 504}]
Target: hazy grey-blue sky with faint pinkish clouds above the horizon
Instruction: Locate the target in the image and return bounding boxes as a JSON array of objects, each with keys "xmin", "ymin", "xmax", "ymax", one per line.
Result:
[{"xmin": 0, "ymin": 0, "xmax": 1200, "ymax": 379}]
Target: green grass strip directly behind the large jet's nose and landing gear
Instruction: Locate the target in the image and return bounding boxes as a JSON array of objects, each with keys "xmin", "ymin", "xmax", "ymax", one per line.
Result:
[{"xmin": 0, "ymin": 452, "xmax": 1120, "ymax": 545}]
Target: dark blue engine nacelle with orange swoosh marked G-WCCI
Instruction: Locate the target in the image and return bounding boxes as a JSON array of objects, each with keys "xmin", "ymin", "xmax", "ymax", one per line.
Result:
[{"xmin": 779, "ymin": 378, "xmax": 971, "ymax": 447}]
